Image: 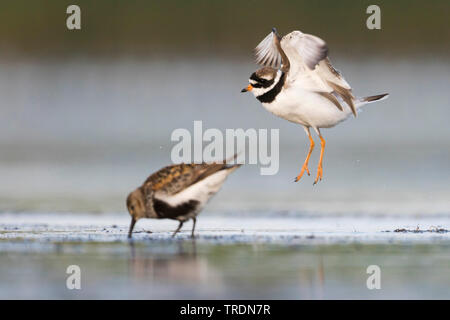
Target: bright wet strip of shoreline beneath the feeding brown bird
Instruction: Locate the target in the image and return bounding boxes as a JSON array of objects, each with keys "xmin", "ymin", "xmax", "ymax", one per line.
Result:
[{"xmin": 0, "ymin": 213, "xmax": 450, "ymax": 244}]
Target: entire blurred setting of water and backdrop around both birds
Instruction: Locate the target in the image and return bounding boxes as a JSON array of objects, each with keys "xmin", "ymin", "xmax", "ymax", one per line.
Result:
[{"xmin": 0, "ymin": 0, "xmax": 450, "ymax": 299}]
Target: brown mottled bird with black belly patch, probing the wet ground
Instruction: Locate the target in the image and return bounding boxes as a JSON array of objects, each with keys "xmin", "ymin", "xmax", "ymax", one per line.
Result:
[{"xmin": 127, "ymin": 163, "xmax": 240, "ymax": 238}]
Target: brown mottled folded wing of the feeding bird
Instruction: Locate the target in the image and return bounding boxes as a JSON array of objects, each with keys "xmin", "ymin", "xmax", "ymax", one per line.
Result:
[{"xmin": 149, "ymin": 163, "xmax": 227, "ymax": 198}]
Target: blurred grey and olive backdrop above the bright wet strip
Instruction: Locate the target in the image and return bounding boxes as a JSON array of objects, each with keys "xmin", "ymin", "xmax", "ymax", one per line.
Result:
[{"xmin": 0, "ymin": 0, "xmax": 450, "ymax": 214}]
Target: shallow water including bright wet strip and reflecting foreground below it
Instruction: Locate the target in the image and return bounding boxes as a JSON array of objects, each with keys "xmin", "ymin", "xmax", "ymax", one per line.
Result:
[{"xmin": 0, "ymin": 213, "xmax": 450, "ymax": 299}]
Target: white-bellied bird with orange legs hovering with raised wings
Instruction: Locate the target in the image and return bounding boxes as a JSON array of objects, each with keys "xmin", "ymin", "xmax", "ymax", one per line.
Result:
[{"xmin": 241, "ymin": 28, "xmax": 388, "ymax": 184}]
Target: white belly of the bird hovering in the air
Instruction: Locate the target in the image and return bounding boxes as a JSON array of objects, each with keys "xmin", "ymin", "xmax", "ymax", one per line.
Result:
[{"xmin": 262, "ymin": 88, "xmax": 351, "ymax": 128}]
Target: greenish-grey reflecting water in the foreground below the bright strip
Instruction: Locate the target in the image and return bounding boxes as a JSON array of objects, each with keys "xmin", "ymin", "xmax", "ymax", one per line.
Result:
[{"xmin": 0, "ymin": 241, "xmax": 450, "ymax": 299}]
